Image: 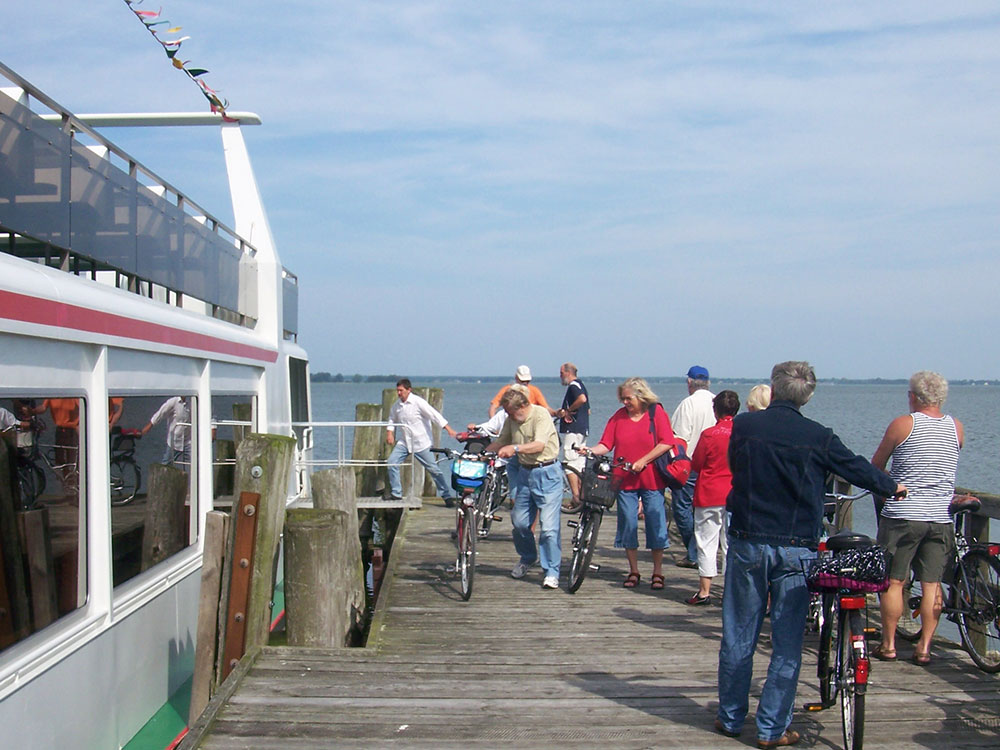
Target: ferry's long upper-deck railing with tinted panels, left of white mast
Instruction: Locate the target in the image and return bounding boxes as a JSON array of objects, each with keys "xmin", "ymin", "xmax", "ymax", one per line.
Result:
[{"xmin": 0, "ymin": 57, "xmax": 262, "ymax": 331}]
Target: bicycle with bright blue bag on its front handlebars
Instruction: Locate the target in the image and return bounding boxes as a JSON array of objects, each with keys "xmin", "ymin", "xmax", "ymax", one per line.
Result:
[{"xmin": 431, "ymin": 448, "xmax": 497, "ymax": 601}]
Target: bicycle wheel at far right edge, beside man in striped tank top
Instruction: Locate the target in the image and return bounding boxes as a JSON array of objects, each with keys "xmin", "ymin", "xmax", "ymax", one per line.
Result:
[{"xmin": 951, "ymin": 549, "xmax": 1000, "ymax": 673}]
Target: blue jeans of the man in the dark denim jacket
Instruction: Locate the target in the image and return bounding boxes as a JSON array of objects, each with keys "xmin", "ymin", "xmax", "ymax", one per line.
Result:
[{"xmin": 718, "ymin": 537, "xmax": 816, "ymax": 741}]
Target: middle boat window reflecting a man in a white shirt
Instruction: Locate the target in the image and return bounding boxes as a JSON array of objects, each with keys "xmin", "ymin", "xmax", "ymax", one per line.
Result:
[{"xmin": 108, "ymin": 394, "xmax": 198, "ymax": 586}]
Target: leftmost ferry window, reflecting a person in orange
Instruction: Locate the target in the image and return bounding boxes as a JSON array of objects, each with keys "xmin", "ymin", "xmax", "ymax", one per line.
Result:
[{"xmin": 0, "ymin": 396, "xmax": 87, "ymax": 649}]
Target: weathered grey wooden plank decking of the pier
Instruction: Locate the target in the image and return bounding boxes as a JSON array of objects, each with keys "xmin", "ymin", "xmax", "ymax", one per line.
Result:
[{"xmin": 189, "ymin": 503, "xmax": 1000, "ymax": 750}]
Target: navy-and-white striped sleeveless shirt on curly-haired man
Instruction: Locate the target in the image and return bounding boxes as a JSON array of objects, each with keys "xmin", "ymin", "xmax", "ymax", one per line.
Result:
[{"xmin": 882, "ymin": 412, "xmax": 959, "ymax": 523}]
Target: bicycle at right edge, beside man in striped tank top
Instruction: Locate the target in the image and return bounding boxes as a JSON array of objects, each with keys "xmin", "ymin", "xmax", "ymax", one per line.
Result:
[{"xmin": 896, "ymin": 495, "xmax": 1000, "ymax": 674}]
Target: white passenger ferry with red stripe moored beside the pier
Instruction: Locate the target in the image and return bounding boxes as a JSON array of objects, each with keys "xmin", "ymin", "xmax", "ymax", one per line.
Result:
[{"xmin": 0, "ymin": 64, "xmax": 310, "ymax": 748}]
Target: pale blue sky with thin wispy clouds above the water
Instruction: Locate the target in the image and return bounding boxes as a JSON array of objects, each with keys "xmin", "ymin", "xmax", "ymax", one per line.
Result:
[{"xmin": 0, "ymin": 0, "xmax": 1000, "ymax": 379}]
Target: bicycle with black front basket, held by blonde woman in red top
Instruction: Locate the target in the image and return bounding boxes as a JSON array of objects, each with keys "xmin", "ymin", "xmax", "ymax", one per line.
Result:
[{"xmin": 563, "ymin": 446, "xmax": 632, "ymax": 594}]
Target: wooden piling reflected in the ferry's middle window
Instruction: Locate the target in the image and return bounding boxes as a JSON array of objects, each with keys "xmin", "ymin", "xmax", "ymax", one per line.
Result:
[{"xmin": 142, "ymin": 464, "xmax": 191, "ymax": 570}]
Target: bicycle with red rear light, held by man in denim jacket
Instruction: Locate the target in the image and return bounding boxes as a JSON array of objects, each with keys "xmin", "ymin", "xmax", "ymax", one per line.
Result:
[{"xmin": 805, "ymin": 524, "xmax": 887, "ymax": 750}]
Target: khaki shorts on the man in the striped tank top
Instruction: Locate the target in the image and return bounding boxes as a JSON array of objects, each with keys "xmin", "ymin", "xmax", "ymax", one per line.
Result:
[{"xmin": 878, "ymin": 518, "xmax": 955, "ymax": 583}]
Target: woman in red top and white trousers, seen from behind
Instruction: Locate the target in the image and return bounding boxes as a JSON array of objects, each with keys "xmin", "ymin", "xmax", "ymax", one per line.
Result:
[{"xmin": 686, "ymin": 391, "xmax": 740, "ymax": 607}]
